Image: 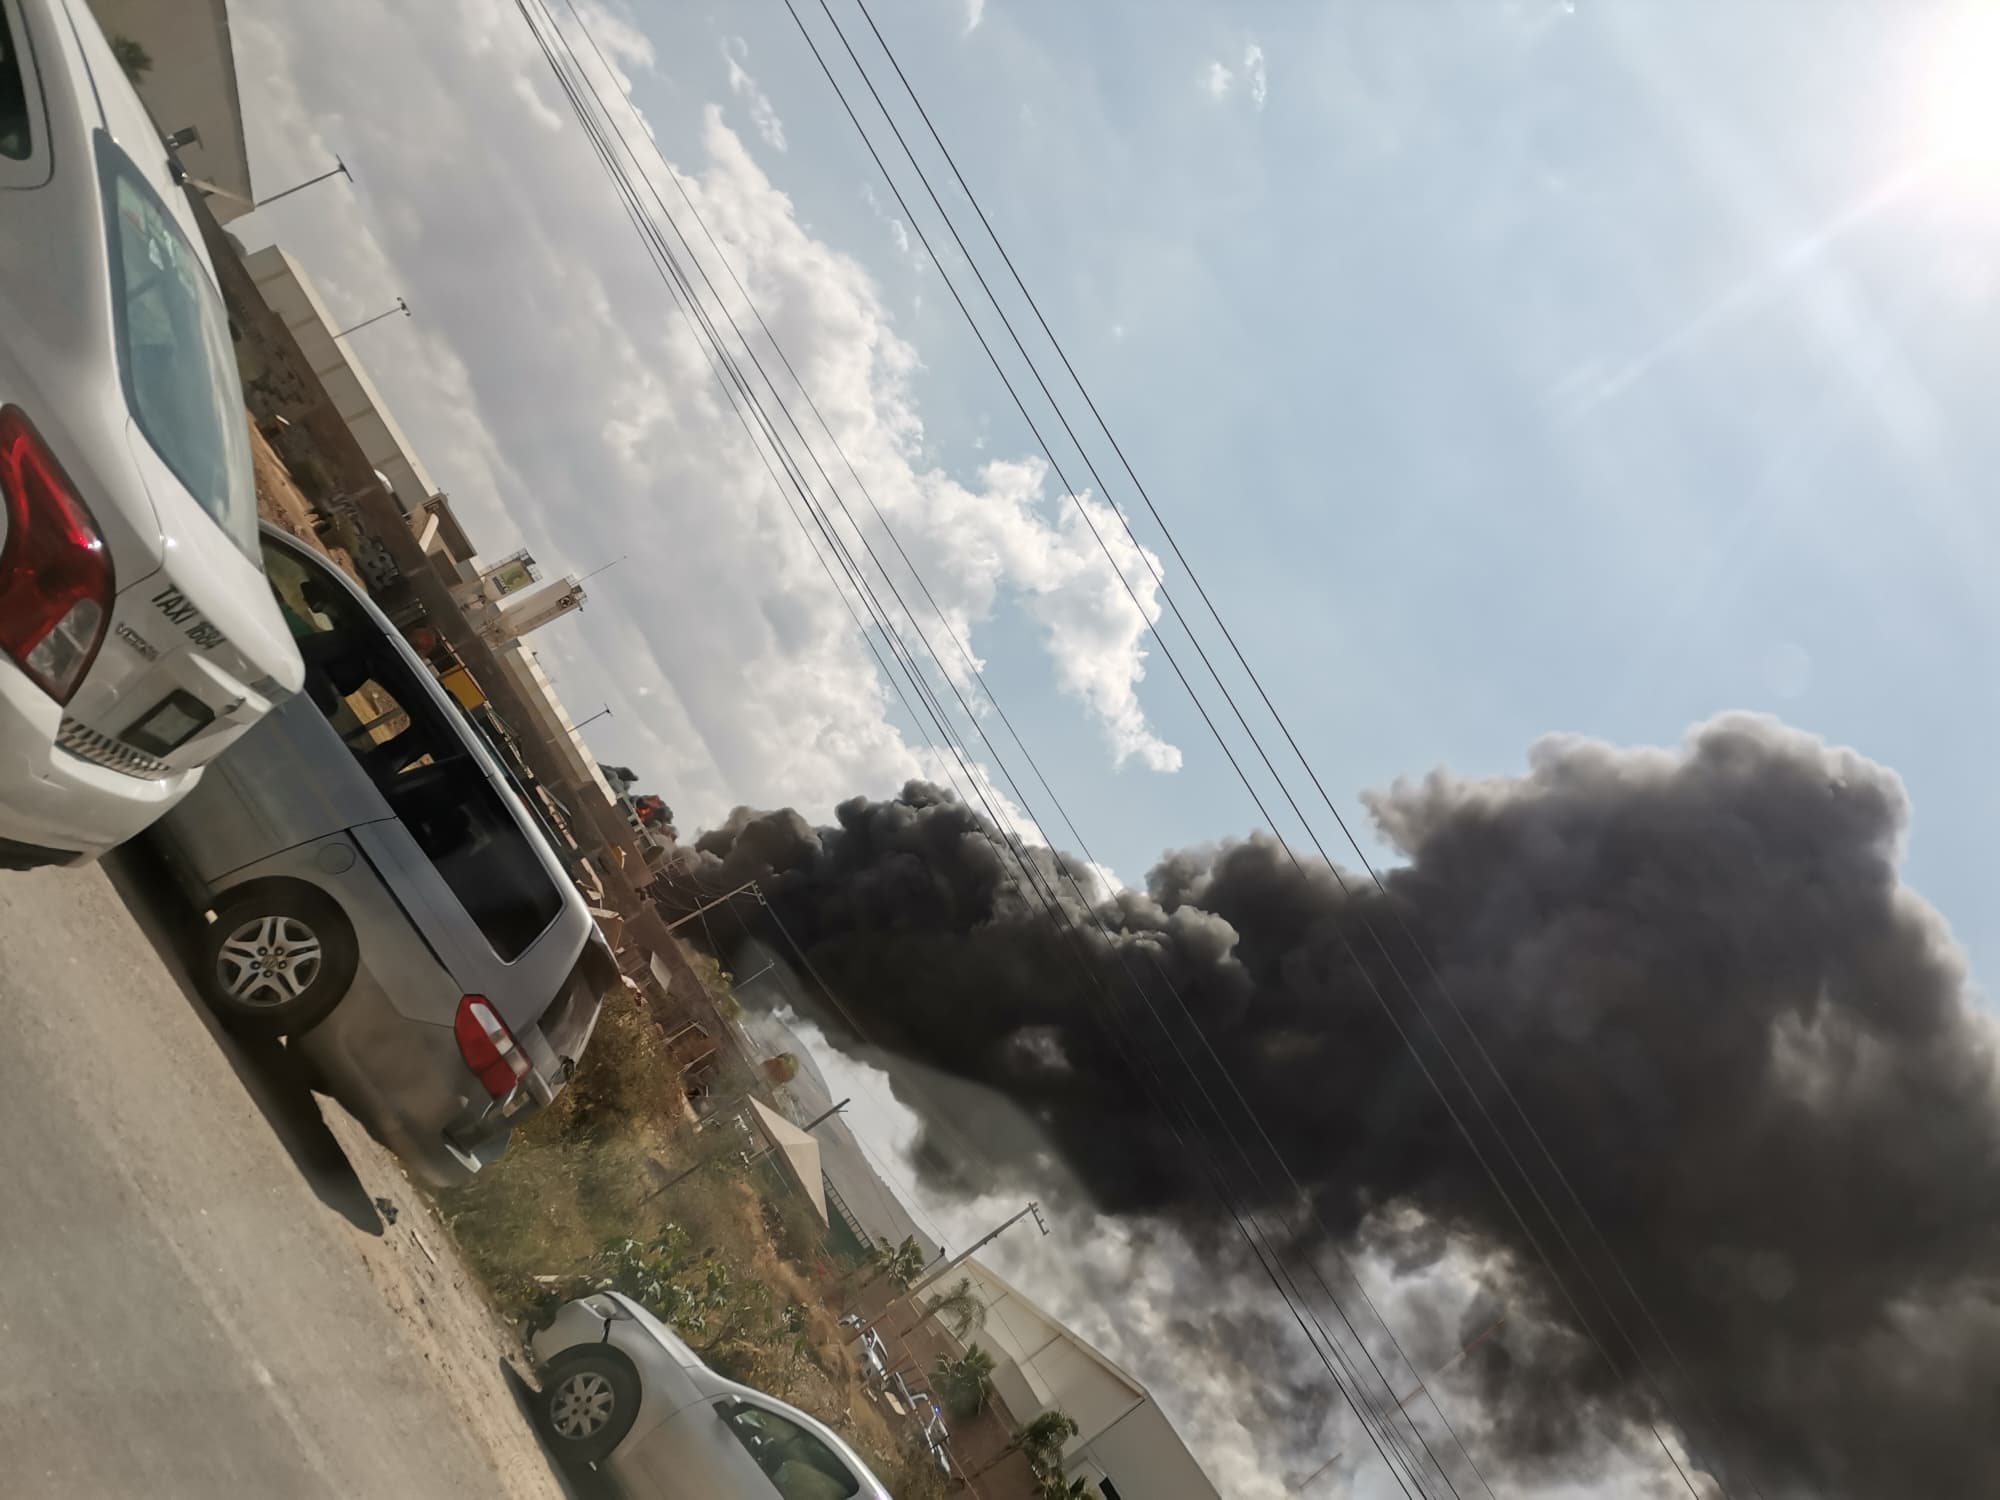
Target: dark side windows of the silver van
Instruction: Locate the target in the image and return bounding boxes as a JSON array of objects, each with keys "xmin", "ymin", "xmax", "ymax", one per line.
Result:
[{"xmin": 282, "ymin": 548, "xmax": 562, "ymax": 962}]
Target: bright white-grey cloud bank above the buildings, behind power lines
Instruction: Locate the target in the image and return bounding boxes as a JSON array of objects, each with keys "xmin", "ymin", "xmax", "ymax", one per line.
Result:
[{"xmin": 236, "ymin": 0, "xmax": 1178, "ymax": 830}]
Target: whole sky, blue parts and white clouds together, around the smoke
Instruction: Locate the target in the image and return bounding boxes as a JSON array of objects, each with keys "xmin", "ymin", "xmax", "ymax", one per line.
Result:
[{"xmin": 232, "ymin": 0, "xmax": 2000, "ymax": 1500}]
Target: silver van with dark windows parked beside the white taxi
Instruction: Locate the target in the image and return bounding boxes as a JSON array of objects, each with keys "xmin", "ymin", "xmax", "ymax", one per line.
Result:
[{"xmin": 156, "ymin": 526, "xmax": 618, "ymax": 1186}]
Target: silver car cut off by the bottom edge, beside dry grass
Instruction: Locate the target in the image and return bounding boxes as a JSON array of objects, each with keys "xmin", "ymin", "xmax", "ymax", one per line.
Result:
[{"xmin": 532, "ymin": 1292, "xmax": 890, "ymax": 1500}]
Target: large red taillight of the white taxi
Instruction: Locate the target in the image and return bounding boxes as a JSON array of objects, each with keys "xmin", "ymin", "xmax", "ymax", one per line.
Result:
[{"xmin": 0, "ymin": 406, "xmax": 114, "ymax": 704}]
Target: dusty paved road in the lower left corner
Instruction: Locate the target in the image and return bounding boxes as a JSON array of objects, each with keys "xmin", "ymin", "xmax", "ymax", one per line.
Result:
[{"xmin": 0, "ymin": 862, "xmax": 532, "ymax": 1500}]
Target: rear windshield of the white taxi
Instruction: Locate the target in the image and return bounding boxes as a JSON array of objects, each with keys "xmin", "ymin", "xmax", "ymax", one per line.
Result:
[{"xmin": 98, "ymin": 136, "xmax": 258, "ymax": 558}]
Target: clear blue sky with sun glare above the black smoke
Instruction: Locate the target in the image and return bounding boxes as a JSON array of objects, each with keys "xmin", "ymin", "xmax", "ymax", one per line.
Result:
[{"xmin": 620, "ymin": 0, "xmax": 2000, "ymax": 980}]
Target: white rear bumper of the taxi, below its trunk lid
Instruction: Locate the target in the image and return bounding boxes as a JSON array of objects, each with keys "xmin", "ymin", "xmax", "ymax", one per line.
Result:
[{"xmin": 0, "ymin": 658, "xmax": 200, "ymax": 868}]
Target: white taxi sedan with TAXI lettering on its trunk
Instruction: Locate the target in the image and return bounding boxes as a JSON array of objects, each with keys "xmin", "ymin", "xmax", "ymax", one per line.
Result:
[{"xmin": 0, "ymin": 0, "xmax": 300, "ymax": 870}]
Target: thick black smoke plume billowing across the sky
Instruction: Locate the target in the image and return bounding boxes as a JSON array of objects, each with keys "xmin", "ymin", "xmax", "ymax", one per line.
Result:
[{"xmin": 696, "ymin": 716, "xmax": 2000, "ymax": 1500}]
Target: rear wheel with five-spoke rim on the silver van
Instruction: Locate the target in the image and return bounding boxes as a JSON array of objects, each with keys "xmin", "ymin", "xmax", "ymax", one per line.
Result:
[{"xmin": 194, "ymin": 880, "xmax": 360, "ymax": 1040}]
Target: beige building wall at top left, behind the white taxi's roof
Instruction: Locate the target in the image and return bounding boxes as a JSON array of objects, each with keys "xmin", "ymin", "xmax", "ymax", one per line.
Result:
[{"xmin": 90, "ymin": 0, "xmax": 256, "ymax": 222}]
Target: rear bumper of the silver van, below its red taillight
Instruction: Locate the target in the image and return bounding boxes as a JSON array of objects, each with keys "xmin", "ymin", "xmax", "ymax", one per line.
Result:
[{"xmin": 296, "ymin": 968, "xmax": 538, "ymax": 1188}]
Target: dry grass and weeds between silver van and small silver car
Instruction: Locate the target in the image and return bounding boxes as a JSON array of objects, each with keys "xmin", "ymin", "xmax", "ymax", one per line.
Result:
[{"xmin": 438, "ymin": 998, "xmax": 944, "ymax": 1500}]
